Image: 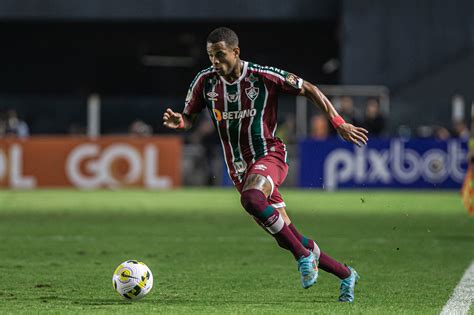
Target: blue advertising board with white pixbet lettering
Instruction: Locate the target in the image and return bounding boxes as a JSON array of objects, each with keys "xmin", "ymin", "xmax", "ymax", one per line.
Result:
[{"xmin": 299, "ymin": 138, "xmax": 467, "ymax": 190}]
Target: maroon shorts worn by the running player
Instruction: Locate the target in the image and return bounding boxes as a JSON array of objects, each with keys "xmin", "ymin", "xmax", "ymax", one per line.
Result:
[{"xmin": 234, "ymin": 152, "xmax": 288, "ymax": 208}]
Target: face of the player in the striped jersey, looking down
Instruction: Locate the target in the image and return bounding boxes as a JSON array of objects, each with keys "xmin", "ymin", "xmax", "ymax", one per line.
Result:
[{"xmin": 207, "ymin": 41, "xmax": 240, "ymax": 76}]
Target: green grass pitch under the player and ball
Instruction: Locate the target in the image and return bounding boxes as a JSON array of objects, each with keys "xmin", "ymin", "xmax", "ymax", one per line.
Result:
[{"xmin": 0, "ymin": 189, "xmax": 474, "ymax": 314}]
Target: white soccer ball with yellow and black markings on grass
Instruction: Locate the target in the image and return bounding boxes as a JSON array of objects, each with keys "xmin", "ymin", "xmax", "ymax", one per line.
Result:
[{"xmin": 112, "ymin": 260, "xmax": 153, "ymax": 301}]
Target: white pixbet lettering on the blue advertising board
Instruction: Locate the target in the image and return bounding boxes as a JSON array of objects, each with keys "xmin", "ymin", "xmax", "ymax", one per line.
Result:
[{"xmin": 324, "ymin": 140, "xmax": 467, "ymax": 190}]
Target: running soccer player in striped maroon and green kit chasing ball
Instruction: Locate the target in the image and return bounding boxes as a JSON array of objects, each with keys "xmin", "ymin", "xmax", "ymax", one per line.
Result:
[{"xmin": 163, "ymin": 27, "xmax": 367, "ymax": 302}]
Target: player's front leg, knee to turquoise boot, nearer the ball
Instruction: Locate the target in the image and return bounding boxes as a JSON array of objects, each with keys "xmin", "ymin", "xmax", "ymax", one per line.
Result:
[{"xmin": 241, "ymin": 174, "xmax": 318, "ymax": 288}]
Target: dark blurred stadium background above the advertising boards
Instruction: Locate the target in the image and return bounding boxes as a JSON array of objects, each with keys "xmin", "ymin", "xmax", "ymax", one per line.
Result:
[{"xmin": 0, "ymin": 0, "xmax": 474, "ymax": 135}]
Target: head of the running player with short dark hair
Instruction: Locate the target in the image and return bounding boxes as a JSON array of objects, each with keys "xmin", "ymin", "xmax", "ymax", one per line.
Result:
[{"xmin": 207, "ymin": 27, "xmax": 240, "ymax": 76}]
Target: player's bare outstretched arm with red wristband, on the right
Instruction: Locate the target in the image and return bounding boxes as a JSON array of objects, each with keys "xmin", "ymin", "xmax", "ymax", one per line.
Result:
[{"xmin": 299, "ymin": 80, "xmax": 368, "ymax": 146}]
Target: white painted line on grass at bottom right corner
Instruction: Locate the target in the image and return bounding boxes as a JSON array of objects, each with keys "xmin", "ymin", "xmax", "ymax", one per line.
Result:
[{"xmin": 441, "ymin": 261, "xmax": 474, "ymax": 315}]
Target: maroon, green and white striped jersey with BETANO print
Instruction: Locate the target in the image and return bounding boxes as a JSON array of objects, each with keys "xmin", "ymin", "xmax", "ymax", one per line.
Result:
[{"xmin": 183, "ymin": 61, "xmax": 303, "ymax": 183}]
